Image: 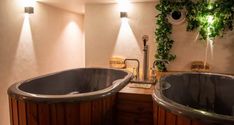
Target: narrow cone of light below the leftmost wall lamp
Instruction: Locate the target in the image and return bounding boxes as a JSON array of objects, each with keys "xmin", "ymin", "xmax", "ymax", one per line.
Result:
[{"xmin": 13, "ymin": 14, "xmax": 38, "ymax": 79}]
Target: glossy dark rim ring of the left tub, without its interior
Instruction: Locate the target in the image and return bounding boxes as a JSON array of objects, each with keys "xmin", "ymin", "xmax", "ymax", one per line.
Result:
[{"xmin": 7, "ymin": 68, "xmax": 132, "ymax": 103}]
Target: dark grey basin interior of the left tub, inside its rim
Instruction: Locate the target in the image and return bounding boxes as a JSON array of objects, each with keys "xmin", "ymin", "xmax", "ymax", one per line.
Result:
[{"xmin": 19, "ymin": 68, "xmax": 127, "ymax": 95}]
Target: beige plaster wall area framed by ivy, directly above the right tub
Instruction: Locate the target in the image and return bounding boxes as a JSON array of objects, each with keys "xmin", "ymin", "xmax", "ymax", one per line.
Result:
[{"xmin": 169, "ymin": 22, "xmax": 234, "ymax": 74}]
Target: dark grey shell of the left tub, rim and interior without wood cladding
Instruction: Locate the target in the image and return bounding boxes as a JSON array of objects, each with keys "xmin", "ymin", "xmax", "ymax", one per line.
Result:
[{"xmin": 8, "ymin": 68, "xmax": 132, "ymax": 102}]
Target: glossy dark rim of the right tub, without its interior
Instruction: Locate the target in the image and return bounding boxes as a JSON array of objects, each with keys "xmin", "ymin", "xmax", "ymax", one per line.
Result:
[{"xmin": 152, "ymin": 72, "xmax": 234, "ymax": 124}]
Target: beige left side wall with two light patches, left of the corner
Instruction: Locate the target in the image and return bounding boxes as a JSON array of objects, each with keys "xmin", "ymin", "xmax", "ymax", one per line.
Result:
[{"xmin": 0, "ymin": 0, "xmax": 84, "ymax": 125}]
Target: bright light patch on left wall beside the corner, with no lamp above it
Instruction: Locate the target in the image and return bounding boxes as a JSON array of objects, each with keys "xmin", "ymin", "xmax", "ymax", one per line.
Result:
[{"xmin": 55, "ymin": 19, "xmax": 85, "ymax": 66}]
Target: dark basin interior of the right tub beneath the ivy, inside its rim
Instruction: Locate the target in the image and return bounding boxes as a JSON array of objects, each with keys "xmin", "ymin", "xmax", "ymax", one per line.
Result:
[{"xmin": 160, "ymin": 73, "xmax": 234, "ymax": 116}]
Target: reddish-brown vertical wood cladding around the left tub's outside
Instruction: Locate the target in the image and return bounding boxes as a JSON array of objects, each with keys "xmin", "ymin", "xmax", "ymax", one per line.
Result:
[{"xmin": 9, "ymin": 96, "xmax": 115, "ymax": 125}]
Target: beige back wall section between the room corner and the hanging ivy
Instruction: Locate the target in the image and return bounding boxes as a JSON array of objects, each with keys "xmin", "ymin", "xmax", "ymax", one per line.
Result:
[{"xmin": 85, "ymin": 2, "xmax": 156, "ymax": 75}]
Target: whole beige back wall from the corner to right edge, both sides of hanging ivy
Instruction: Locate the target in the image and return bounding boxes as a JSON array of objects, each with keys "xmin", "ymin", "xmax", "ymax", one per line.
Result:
[{"xmin": 85, "ymin": 2, "xmax": 234, "ymax": 73}]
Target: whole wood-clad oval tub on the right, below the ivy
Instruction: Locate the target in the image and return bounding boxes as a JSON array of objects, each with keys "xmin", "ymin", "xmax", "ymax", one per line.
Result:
[{"xmin": 153, "ymin": 73, "xmax": 234, "ymax": 125}]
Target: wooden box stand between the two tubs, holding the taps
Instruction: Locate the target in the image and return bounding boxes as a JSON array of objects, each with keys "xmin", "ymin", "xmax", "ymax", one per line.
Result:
[{"xmin": 116, "ymin": 83, "xmax": 154, "ymax": 125}]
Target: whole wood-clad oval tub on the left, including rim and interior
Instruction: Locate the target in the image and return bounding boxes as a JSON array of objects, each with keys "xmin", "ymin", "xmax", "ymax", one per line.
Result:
[{"xmin": 8, "ymin": 68, "xmax": 132, "ymax": 125}]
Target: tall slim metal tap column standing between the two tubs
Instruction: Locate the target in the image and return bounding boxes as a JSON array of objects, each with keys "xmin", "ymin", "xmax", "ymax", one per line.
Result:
[{"xmin": 142, "ymin": 35, "xmax": 149, "ymax": 81}]
